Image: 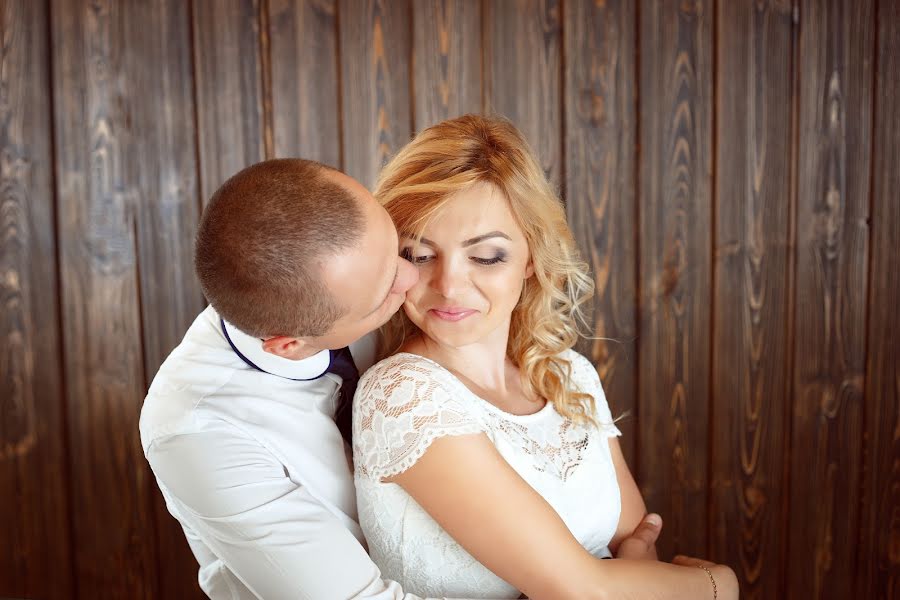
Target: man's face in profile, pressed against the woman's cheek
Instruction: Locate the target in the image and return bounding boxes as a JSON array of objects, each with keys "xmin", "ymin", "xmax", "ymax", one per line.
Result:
[{"xmin": 306, "ymin": 173, "xmax": 419, "ymax": 349}]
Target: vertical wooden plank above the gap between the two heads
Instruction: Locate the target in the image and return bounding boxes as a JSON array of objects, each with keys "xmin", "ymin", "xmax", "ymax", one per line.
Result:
[{"xmin": 339, "ymin": 0, "xmax": 412, "ymax": 189}]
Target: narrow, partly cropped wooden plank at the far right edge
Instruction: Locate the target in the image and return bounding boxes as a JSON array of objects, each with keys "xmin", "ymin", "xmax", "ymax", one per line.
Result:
[{"xmin": 855, "ymin": 0, "xmax": 900, "ymax": 600}]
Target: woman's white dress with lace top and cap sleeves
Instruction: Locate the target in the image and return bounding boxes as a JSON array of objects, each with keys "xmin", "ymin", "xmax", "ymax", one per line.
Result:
[{"xmin": 353, "ymin": 351, "xmax": 621, "ymax": 598}]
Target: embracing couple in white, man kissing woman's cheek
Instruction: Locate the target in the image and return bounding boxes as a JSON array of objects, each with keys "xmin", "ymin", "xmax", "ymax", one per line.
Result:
[{"xmin": 141, "ymin": 115, "xmax": 738, "ymax": 600}]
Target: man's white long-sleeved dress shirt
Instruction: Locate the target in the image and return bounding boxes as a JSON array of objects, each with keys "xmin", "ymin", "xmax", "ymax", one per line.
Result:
[{"xmin": 140, "ymin": 307, "xmax": 446, "ymax": 600}]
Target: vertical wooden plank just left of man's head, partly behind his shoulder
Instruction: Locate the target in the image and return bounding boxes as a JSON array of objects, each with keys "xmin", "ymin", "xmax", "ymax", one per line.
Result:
[{"xmin": 126, "ymin": 0, "xmax": 207, "ymax": 598}]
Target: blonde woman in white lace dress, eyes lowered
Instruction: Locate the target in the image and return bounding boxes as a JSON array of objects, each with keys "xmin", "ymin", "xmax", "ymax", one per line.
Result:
[{"xmin": 354, "ymin": 115, "xmax": 737, "ymax": 600}]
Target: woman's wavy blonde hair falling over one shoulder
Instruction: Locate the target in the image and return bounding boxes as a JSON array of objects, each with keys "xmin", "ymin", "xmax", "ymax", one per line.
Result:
[{"xmin": 375, "ymin": 115, "xmax": 596, "ymax": 423}]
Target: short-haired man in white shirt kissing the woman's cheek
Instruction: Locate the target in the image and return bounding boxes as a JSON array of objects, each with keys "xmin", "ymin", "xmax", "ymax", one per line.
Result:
[{"xmin": 140, "ymin": 159, "xmax": 659, "ymax": 600}]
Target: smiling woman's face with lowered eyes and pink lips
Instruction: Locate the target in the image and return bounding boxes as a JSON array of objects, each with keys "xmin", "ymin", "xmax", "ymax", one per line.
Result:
[{"xmin": 400, "ymin": 183, "xmax": 533, "ymax": 348}]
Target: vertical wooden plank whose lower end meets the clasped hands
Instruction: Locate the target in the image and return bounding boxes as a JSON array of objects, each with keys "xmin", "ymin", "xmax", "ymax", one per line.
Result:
[{"xmin": 638, "ymin": 0, "xmax": 713, "ymax": 558}]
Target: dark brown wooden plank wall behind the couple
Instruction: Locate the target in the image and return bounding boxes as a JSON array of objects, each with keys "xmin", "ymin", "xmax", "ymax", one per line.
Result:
[{"xmin": 0, "ymin": 0, "xmax": 900, "ymax": 600}]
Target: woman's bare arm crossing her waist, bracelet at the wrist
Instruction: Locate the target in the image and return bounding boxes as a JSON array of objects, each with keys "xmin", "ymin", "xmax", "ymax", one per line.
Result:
[{"xmin": 388, "ymin": 434, "xmax": 737, "ymax": 600}]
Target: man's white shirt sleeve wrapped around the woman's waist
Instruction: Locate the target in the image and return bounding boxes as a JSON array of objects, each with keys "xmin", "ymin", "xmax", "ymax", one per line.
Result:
[{"xmin": 147, "ymin": 422, "xmax": 458, "ymax": 600}]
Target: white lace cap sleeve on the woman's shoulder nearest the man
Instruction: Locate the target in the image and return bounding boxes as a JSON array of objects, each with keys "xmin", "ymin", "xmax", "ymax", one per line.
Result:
[{"xmin": 353, "ymin": 354, "xmax": 484, "ymax": 480}]
